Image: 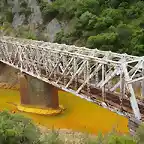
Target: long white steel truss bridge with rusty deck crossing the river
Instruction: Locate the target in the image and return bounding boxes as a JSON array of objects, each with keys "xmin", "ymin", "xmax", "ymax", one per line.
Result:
[{"xmin": 0, "ymin": 36, "xmax": 144, "ymax": 120}]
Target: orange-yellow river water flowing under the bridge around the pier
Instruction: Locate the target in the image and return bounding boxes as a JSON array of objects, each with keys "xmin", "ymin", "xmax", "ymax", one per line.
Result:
[{"xmin": 0, "ymin": 89, "xmax": 128, "ymax": 134}]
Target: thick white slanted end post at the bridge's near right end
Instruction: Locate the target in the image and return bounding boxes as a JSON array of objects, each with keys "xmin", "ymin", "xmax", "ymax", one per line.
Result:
[{"xmin": 122, "ymin": 63, "xmax": 141, "ymax": 120}]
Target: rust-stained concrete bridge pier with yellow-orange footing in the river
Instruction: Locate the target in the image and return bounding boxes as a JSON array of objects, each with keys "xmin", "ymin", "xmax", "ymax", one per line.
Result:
[{"xmin": 18, "ymin": 74, "xmax": 63, "ymax": 115}]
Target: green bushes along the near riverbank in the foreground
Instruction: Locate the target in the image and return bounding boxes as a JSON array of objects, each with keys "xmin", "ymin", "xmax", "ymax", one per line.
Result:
[{"xmin": 0, "ymin": 111, "xmax": 144, "ymax": 144}]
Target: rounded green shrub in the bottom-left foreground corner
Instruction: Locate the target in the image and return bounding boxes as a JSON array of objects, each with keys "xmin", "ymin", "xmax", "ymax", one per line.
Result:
[{"xmin": 0, "ymin": 111, "xmax": 40, "ymax": 144}]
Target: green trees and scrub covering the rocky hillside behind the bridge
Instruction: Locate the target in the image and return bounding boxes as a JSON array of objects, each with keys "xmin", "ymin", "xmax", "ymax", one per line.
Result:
[{"xmin": 0, "ymin": 0, "xmax": 144, "ymax": 55}]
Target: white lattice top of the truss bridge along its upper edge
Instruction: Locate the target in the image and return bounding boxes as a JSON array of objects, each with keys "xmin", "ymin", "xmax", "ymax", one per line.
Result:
[{"xmin": 0, "ymin": 36, "xmax": 144, "ymax": 64}]
